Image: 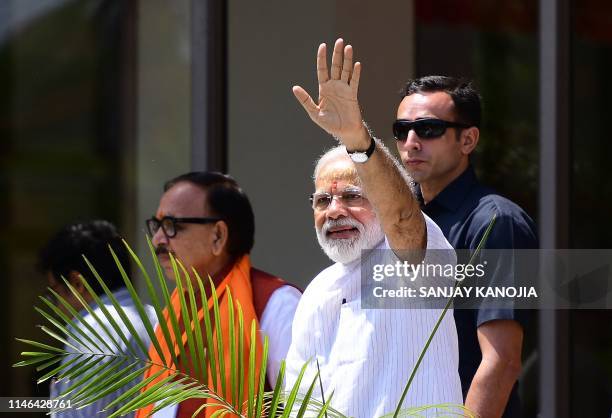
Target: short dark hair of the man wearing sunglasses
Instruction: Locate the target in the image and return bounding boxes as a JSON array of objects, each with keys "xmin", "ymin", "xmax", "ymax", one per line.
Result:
[{"xmin": 403, "ymin": 75, "xmax": 481, "ymax": 128}]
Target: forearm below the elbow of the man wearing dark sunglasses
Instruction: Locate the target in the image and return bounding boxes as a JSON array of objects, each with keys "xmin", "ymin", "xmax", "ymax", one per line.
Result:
[{"xmin": 465, "ymin": 359, "xmax": 520, "ymax": 418}]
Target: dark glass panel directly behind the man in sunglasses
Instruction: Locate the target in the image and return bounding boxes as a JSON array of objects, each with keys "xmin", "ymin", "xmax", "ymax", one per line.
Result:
[{"xmin": 415, "ymin": 0, "xmax": 539, "ymax": 417}]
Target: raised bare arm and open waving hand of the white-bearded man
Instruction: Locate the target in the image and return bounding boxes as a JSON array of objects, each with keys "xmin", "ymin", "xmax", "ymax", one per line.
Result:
[{"xmin": 293, "ymin": 39, "xmax": 427, "ymax": 250}]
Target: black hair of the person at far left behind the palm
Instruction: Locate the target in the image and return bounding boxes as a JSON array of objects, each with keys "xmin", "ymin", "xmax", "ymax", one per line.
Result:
[{"xmin": 38, "ymin": 220, "xmax": 131, "ymax": 295}]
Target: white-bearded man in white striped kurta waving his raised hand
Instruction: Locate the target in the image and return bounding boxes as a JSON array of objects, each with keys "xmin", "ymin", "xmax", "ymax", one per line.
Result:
[{"xmin": 286, "ymin": 39, "xmax": 462, "ymax": 418}]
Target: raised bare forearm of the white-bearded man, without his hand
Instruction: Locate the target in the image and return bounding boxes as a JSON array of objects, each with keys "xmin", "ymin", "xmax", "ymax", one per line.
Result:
[{"xmin": 354, "ymin": 127, "xmax": 427, "ymax": 250}]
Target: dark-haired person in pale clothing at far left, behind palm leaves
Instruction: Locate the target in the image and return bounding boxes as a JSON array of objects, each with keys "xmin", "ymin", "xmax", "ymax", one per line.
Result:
[{"xmin": 38, "ymin": 220, "xmax": 157, "ymax": 418}]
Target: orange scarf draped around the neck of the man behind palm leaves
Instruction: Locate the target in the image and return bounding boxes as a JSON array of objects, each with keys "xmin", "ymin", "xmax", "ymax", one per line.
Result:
[{"xmin": 136, "ymin": 255, "xmax": 265, "ymax": 418}]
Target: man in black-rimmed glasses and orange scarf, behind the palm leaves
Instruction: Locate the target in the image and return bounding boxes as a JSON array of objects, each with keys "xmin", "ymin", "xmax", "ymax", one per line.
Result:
[{"xmin": 137, "ymin": 172, "xmax": 301, "ymax": 417}]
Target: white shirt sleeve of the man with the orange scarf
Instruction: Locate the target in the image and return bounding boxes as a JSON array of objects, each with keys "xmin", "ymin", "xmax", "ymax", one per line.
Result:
[{"xmin": 259, "ymin": 286, "xmax": 302, "ymax": 388}]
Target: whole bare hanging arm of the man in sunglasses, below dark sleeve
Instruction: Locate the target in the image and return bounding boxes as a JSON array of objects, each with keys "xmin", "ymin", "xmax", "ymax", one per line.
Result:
[{"xmin": 465, "ymin": 320, "xmax": 523, "ymax": 418}]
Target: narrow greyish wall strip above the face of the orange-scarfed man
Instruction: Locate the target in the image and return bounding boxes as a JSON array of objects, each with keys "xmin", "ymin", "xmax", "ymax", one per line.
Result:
[{"xmin": 134, "ymin": 0, "xmax": 191, "ymax": 284}]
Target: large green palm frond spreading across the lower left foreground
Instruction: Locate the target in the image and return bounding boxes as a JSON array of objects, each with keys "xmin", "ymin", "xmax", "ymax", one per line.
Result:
[{"xmin": 14, "ymin": 237, "xmax": 328, "ymax": 417}]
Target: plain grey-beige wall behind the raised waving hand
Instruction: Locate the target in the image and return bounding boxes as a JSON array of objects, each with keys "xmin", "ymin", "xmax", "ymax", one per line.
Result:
[{"xmin": 228, "ymin": 0, "xmax": 414, "ymax": 285}]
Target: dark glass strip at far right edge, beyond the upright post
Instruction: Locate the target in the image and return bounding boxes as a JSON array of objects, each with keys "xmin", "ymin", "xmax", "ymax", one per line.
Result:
[{"xmin": 569, "ymin": 1, "xmax": 612, "ymax": 417}]
